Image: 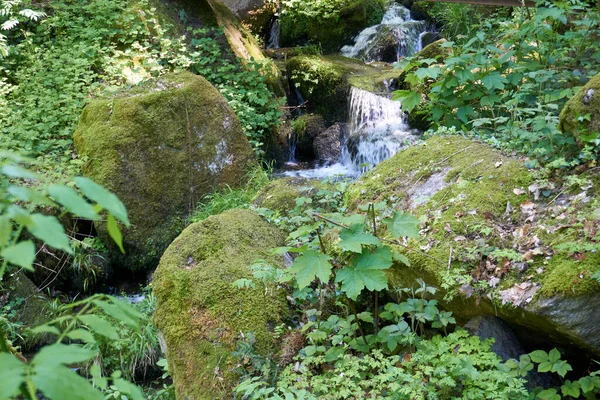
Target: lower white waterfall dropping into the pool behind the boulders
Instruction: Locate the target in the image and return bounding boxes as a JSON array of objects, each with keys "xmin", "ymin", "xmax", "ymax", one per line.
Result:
[{"xmin": 340, "ymin": 87, "xmax": 416, "ymax": 172}]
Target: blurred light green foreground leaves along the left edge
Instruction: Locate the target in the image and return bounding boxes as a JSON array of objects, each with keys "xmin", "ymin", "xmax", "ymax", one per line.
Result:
[{"xmin": 0, "ymin": 153, "xmax": 144, "ymax": 399}]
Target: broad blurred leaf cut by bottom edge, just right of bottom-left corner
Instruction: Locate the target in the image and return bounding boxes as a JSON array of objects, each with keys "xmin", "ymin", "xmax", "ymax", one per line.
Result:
[{"xmin": 33, "ymin": 366, "xmax": 104, "ymax": 400}]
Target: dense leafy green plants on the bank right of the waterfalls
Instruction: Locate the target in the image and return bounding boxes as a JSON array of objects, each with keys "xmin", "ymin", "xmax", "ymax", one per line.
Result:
[{"xmin": 396, "ymin": 1, "xmax": 600, "ymax": 166}]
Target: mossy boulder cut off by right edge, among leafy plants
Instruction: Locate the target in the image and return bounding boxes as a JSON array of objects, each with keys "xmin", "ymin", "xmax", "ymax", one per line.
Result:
[{"xmin": 558, "ymin": 74, "xmax": 600, "ymax": 144}]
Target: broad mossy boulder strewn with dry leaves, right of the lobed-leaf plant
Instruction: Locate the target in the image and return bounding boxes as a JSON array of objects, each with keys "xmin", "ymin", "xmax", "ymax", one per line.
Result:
[{"xmin": 347, "ymin": 136, "xmax": 600, "ymax": 354}]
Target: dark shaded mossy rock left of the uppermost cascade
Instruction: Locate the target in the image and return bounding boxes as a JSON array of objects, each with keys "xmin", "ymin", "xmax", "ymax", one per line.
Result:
[{"xmin": 281, "ymin": 0, "xmax": 384, "ymax": 53}]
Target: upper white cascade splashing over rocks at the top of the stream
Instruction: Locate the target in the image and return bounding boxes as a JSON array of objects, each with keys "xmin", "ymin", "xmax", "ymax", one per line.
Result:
[{"xmin": 341, "ymin": 4, "xmax": 426, "ymax": 62}]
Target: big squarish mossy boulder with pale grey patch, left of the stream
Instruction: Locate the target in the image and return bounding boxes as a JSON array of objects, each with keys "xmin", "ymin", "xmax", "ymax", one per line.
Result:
[{"xmin": 75, "ymin": 73, "xmax": 255, "ymax": 271}]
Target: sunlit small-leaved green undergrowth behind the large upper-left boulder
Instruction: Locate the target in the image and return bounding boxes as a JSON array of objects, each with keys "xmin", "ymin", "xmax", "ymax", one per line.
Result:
[{"xmin": 0, "ymin": 0, "xmax": 281, "ymax": 178}]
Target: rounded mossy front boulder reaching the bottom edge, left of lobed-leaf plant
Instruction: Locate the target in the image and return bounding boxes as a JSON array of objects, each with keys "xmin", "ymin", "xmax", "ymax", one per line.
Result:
[{"xmin": 153, "ymin": 210, "xmax": 287, "ymax": 400}]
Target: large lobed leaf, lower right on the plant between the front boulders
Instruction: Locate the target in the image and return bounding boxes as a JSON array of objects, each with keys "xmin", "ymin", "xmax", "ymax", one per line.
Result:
[{"xmin": 335, "ymin": 246, "xmax": 392, "ymax": 300}]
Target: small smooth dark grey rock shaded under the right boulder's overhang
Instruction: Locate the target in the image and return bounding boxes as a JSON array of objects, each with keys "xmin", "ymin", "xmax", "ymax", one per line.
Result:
[{"xmin": 464, "ymin": 315, "xmax": 525, "ymax": 361}]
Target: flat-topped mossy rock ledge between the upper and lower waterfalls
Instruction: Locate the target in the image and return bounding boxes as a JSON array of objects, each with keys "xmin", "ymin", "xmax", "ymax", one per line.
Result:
[{"xmin": 286, "ymin": 56, "xmax": 400, "ymax": 123}]
